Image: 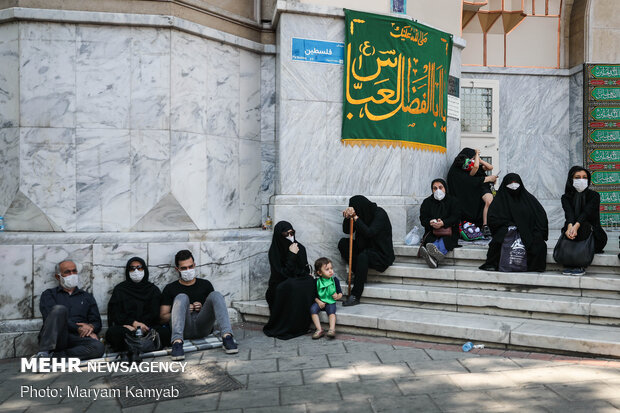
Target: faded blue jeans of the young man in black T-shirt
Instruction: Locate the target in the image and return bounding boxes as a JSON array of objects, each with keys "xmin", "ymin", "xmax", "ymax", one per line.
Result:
[{"xmin": 170, "ymin": 291, "xmax": 232, "ymax": 343}]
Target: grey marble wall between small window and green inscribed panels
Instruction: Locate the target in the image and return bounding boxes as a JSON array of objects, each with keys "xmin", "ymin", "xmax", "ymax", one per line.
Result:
[{"xmin": 462, "ymin": 69, "xmax": 583, "ymax": 229}]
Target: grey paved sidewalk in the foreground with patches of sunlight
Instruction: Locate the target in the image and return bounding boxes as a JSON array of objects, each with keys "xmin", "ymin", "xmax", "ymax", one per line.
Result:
[{"xmin": 0, "ymin": 324, "xmax": 620, "ymax": 413}]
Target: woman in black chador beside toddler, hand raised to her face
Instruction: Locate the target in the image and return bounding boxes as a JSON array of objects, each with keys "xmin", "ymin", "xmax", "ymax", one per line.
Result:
[{"xmin": 263, "ymin": 221, "xmax": 315, "ymax": 340}]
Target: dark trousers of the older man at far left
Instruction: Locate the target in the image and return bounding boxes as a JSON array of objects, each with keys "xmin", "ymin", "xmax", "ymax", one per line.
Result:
[{"xmin": 39, "ymin": 305, "xmax": 105, "ymax": 360}]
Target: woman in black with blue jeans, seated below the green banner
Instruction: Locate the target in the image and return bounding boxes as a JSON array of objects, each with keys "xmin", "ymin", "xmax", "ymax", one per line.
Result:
[{"xmin": 420, "ymin": 178, "xmax": 460, "ymax": 268}]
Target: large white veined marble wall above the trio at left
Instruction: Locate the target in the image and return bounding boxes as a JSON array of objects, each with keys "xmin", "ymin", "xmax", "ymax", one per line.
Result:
[{"xmin": 0, "ymin": 21, "xmax": 275, "ymax": 232}]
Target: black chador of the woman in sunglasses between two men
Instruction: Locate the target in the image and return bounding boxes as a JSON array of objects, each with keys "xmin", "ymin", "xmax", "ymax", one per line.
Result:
[{"xmin": 108, "ymin": 257, "xmax": 161, "ymax": 326}]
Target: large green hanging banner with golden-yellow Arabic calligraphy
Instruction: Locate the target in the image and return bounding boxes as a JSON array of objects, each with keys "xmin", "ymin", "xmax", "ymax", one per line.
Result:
[{"xmin": 342, "ymin": 9, "xmax": 452, "ymax": 153}]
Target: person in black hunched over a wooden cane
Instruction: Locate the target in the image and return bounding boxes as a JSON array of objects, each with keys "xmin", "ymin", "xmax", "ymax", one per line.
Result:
[{"xmin": 338, "ymin": 195, "xmax": 394, "ymax": 306}]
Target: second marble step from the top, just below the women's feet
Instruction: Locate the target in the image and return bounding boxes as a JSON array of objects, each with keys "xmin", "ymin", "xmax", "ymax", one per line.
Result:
[{"xmin": 369, "ymin": 263, "xmax": 620, "ymax": 299}]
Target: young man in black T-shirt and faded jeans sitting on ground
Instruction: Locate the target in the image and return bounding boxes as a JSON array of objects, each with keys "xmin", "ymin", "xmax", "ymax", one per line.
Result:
[{"xmin": 160, "ymin": 250, "xmax": 239, "ymax": 360}]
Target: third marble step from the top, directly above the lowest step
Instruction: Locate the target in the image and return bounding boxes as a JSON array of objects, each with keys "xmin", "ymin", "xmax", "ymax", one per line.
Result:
[{"xmin": 362, "ymin": 283, "xmax": 620, "ymax": 325}]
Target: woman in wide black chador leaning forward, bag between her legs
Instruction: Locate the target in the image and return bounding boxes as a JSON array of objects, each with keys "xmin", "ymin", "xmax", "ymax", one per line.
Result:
[{"xmin": 480, "ymin": 173, "xmax": 549, "ymax": 272}]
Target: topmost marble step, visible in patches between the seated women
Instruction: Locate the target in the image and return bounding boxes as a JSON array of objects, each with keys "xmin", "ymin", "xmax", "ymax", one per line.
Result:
[{"xmin": 394, "ymin": 244, "xmax": 620, "ymax": 274}]
